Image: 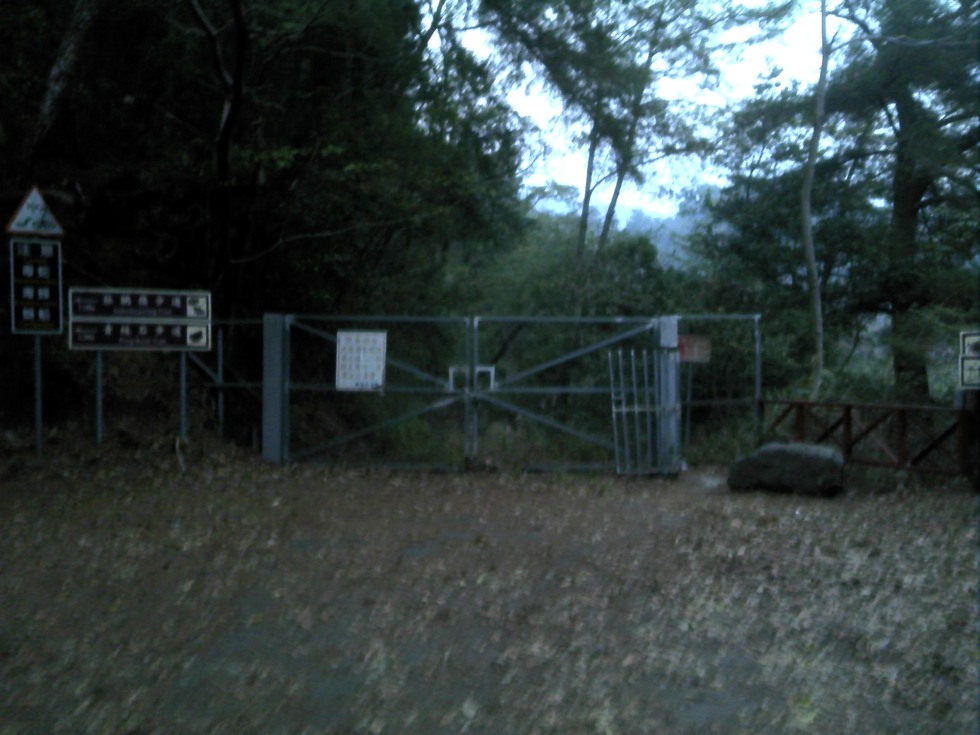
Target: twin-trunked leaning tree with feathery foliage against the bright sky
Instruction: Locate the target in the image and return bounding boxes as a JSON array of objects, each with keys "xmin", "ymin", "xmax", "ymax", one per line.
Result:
[{"xmin": 480, "ymin": 0, "xmax": 789, "ymax": 284}]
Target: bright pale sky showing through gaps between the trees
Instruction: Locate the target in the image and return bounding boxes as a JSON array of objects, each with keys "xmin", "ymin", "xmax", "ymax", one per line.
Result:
[{"xmin": 474, "ymin": 0, "xmax": 844, "ymax": 222}]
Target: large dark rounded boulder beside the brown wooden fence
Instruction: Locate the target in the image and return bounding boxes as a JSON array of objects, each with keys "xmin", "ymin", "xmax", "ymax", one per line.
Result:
[{"xmin": 728, "ymin": 442, "xmax": 844, "ymax": 498}]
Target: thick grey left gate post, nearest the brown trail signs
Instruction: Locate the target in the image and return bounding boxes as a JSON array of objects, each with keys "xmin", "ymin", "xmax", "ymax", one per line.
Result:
[{"xmin": 262, "ymin": 314, "xmax": 289, "ymax": 464}]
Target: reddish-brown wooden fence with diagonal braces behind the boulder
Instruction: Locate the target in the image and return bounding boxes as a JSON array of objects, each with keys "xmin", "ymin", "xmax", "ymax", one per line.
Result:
[{"xmin": 760, "ymin": 400, "xmax": 980, "ymax": 482}]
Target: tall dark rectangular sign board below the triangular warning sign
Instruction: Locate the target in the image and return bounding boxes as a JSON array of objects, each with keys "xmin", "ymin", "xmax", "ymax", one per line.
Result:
[{"xmin": 10, "ymin": 237, "xmax": 63, "ymax": 334}]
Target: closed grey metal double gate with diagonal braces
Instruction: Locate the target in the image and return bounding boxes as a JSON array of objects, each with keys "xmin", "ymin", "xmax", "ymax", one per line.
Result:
[{"xmin": 262, "ymin": 314, "xmax": 681, "ymax": 474}]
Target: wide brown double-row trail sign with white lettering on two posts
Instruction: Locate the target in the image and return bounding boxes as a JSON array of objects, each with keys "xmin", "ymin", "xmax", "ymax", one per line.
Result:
[{"xmin": 68, "ymin": 288, "xmax": 211, "ymax": 351}]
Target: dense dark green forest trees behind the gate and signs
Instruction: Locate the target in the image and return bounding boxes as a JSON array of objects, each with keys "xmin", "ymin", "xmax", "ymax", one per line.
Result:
[{"xmin": 0, "ymin": 0, "xmax": 980, "ymax": 426}]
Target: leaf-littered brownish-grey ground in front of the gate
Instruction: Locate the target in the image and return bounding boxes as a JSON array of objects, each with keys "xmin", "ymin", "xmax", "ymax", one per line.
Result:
[{"xmin": 0, "ymin": 444, "xmax": 978, "ymax": 735}]
